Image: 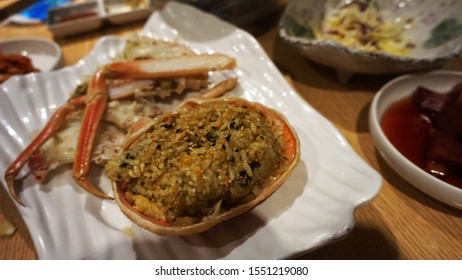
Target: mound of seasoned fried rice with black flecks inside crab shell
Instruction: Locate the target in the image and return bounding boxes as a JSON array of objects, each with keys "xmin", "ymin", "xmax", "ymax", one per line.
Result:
[{"xmin": 106, "ymin": 101, "xmax": 286, "ymax": 222}]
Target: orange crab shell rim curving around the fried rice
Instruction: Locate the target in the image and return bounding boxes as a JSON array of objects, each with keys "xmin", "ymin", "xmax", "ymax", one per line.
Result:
[{"xmin": 112, "ymin": 98, "xmax": 300, "ymax": 236}]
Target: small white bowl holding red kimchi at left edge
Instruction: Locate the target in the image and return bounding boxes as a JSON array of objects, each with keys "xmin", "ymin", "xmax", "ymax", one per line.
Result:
[{"xmin": 0, "ymin": 37, "xmax": 62, "ymax": 72}]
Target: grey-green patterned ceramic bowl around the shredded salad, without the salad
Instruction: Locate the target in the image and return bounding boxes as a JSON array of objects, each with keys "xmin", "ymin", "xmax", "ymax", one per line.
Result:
[{"xmin": 279, "ymin": 0, "xmax": 462, "ymax": 81}]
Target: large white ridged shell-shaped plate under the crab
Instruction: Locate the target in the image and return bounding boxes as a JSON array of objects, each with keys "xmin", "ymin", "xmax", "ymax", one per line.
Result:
[{"xmin": 0, "ymin": 2, "xmax": 382, "ymax": 259}]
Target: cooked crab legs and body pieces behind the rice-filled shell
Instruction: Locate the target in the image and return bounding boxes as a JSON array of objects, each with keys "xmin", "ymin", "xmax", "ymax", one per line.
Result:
[{"xmin": 5, "ymin": 38, "xmax": 236, "ymax": 204}]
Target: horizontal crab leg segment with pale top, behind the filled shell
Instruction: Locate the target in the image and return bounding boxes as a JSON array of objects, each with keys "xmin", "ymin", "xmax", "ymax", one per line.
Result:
[{"xmin": 104, "ymin": 54, "xmax": 236, "ymax": 79}]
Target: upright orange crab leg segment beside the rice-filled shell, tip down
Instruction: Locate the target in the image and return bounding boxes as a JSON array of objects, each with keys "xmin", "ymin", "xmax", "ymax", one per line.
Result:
[{"xmin": 73, "ymin": 71, "xmax": 111, "ymax": 199}]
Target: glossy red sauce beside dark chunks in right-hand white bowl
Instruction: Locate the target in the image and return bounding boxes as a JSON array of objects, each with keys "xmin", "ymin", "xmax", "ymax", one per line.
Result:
[{"xmin": 381, "ymin": 85, "xmax": 462, "ymax": 189}]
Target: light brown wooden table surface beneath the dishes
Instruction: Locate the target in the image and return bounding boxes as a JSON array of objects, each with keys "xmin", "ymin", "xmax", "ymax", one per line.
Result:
[{"xmin": 0, "ymin": 2, "xmax": 462, "ymax": 259}]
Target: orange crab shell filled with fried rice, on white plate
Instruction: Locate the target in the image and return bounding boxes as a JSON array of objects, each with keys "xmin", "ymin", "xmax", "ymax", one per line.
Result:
[{"xmin": 106, "ymin": 98, "xmax": 300, "ymax": 235}]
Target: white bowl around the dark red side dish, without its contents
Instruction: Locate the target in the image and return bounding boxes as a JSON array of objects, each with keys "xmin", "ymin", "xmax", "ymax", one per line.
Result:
[{"xmin": 369, "ymin": 71, "xmax": 462, "ymax": 209}]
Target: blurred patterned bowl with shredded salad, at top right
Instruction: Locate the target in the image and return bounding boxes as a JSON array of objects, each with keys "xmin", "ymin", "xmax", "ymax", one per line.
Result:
[{"xmin": 279, "ymin": 0, "xmax": 462, "ymax": 82}]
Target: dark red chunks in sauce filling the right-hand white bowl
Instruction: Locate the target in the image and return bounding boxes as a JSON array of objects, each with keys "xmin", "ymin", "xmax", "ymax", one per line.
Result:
[{"xmin": 381, "ymin": 83, "xmax": 462, "ymax": 188}]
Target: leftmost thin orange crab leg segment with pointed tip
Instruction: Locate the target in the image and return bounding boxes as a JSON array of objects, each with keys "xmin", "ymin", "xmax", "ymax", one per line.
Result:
[{"xmin": 5, "ymin": 97, "xmax": 84, "ymax": 205}]
